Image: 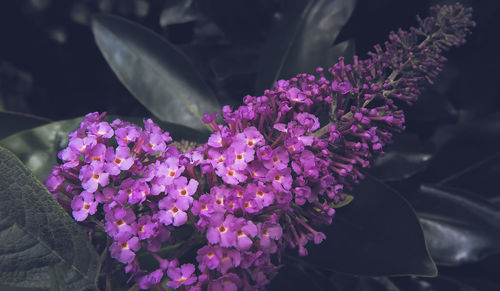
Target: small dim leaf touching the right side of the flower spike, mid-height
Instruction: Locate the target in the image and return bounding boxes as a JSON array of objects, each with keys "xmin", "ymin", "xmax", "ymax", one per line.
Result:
[{"xmin": 369, "ymin": 133, "xmax": 432, "ymax": 181}]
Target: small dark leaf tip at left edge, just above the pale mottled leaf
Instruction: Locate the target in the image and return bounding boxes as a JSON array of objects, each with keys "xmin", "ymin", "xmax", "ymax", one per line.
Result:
[{"xmin": 0, "ymin": 110, "xmax": 50, "ymax": 139}]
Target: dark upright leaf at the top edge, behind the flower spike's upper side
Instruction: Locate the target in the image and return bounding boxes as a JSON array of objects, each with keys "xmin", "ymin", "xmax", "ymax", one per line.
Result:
[{"xmin": 255, "ymin": 0, "xmax": 356, "ymax": 94}]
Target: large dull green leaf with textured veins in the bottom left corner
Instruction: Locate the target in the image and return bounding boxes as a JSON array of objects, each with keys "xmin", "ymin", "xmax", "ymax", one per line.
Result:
[{"xmin": 0, "ymin": 147, "xmax": 100, "ymax": 290}]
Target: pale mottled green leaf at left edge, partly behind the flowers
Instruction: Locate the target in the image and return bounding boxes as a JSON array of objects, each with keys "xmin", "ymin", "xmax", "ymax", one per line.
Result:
[{"xmin": 0, "ymin": 117, "xmax": 82, "ymax": 181}]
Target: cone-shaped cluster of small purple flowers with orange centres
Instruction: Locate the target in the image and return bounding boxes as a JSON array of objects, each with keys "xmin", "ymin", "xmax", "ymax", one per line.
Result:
[{"xmin": 46, "ymin": 5, "xmax": 474, "ymax": 290}]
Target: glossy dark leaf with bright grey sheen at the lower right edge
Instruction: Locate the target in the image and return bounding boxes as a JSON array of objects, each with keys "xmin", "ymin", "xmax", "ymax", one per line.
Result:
[{"xmin": 412, "ymin": 185, "xmax": 500, "ymax": 266}]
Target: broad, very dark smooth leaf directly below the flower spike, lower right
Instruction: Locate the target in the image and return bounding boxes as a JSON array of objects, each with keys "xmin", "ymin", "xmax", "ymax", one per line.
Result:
[{"xmin": 308, "ymin": 177, "xmax": 437, "ymax": 276}]
